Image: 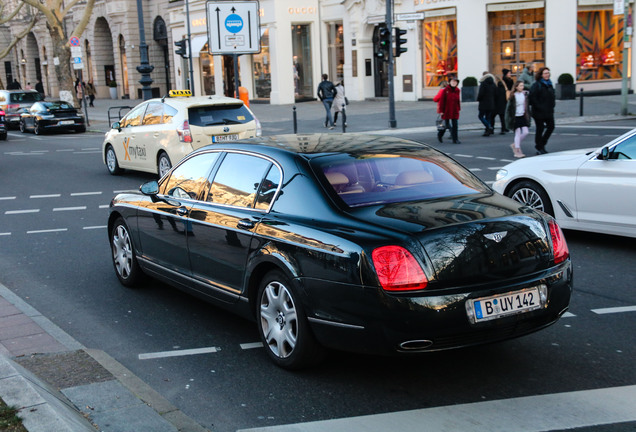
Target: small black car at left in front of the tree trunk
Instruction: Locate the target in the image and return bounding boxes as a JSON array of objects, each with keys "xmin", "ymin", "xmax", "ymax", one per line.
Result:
[{"xmin": 20, "ymin": 101, "xmax": 86, "ymax": 135}]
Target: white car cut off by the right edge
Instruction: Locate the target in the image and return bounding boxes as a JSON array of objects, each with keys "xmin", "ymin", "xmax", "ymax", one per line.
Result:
[{"xmin": 493, "ymin": 129, "xmax": 636, "ymax": 237}]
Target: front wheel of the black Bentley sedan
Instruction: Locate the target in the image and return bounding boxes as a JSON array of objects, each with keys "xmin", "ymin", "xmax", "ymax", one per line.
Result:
[{"xmin": 110, "ymin": 218, "xmax": 143, "ymax": 287}]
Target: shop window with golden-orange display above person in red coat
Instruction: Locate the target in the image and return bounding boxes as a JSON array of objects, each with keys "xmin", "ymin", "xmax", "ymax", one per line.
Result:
[{"xmin": 422, "ymin": 17, "xmax": 457, "ymax": 87}]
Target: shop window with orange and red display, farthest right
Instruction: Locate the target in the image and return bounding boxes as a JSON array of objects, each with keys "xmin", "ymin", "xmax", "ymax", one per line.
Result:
[{"xmin": 576, "ymin": 9, "xmax": 624, "ymax": 81}]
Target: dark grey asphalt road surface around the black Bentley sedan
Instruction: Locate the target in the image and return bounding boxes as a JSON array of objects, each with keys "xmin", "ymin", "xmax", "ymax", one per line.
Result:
[{"xmin": 0, "ymin": 121, "xmax": 636, "ymax": 431}]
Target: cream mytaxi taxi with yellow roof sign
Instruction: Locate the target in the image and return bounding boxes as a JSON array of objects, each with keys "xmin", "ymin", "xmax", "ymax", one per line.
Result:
[{"xmin": 102, "ymin": 90, "xmax": 261, "ymax": 177}]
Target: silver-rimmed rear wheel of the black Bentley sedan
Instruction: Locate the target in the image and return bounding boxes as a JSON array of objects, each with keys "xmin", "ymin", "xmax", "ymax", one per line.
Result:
[{"xmin": 256, "ymin": 271, "xmax": 324, "ymax": 370}]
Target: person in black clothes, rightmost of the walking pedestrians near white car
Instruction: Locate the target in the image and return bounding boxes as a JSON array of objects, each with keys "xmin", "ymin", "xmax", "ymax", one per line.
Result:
[{"xmin": 530, "ymin": 67, "xmax": 556, "ymax": 154}]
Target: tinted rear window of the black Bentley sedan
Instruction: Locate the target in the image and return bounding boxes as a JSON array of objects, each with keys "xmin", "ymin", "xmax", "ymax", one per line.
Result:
[{"xmin": 312, "ymin": 154, "xmax": 490, "ymax": 207}]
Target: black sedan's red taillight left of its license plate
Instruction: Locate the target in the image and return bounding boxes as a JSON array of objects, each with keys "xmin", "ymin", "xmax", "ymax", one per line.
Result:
[{"xmin": 371, "ymin": 246, "xmax": 428, "ymax": 292}]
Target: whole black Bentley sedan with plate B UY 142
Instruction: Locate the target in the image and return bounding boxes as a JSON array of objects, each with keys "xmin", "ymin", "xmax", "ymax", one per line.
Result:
[{"xmin": 108, "ymin": 134, "xmax": 572, "ymax": 369}]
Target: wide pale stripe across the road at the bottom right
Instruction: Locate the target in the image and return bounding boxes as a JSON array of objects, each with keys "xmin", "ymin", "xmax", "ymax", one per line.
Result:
[{"xmin": 239, "ymin": 385, "xmax": 636, "ymax": 432}]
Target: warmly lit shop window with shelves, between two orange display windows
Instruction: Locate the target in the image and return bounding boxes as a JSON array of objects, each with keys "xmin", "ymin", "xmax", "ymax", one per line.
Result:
[{"xmin": 488, "ymin": 8, "xmax": 545, "ymax": 77}]
